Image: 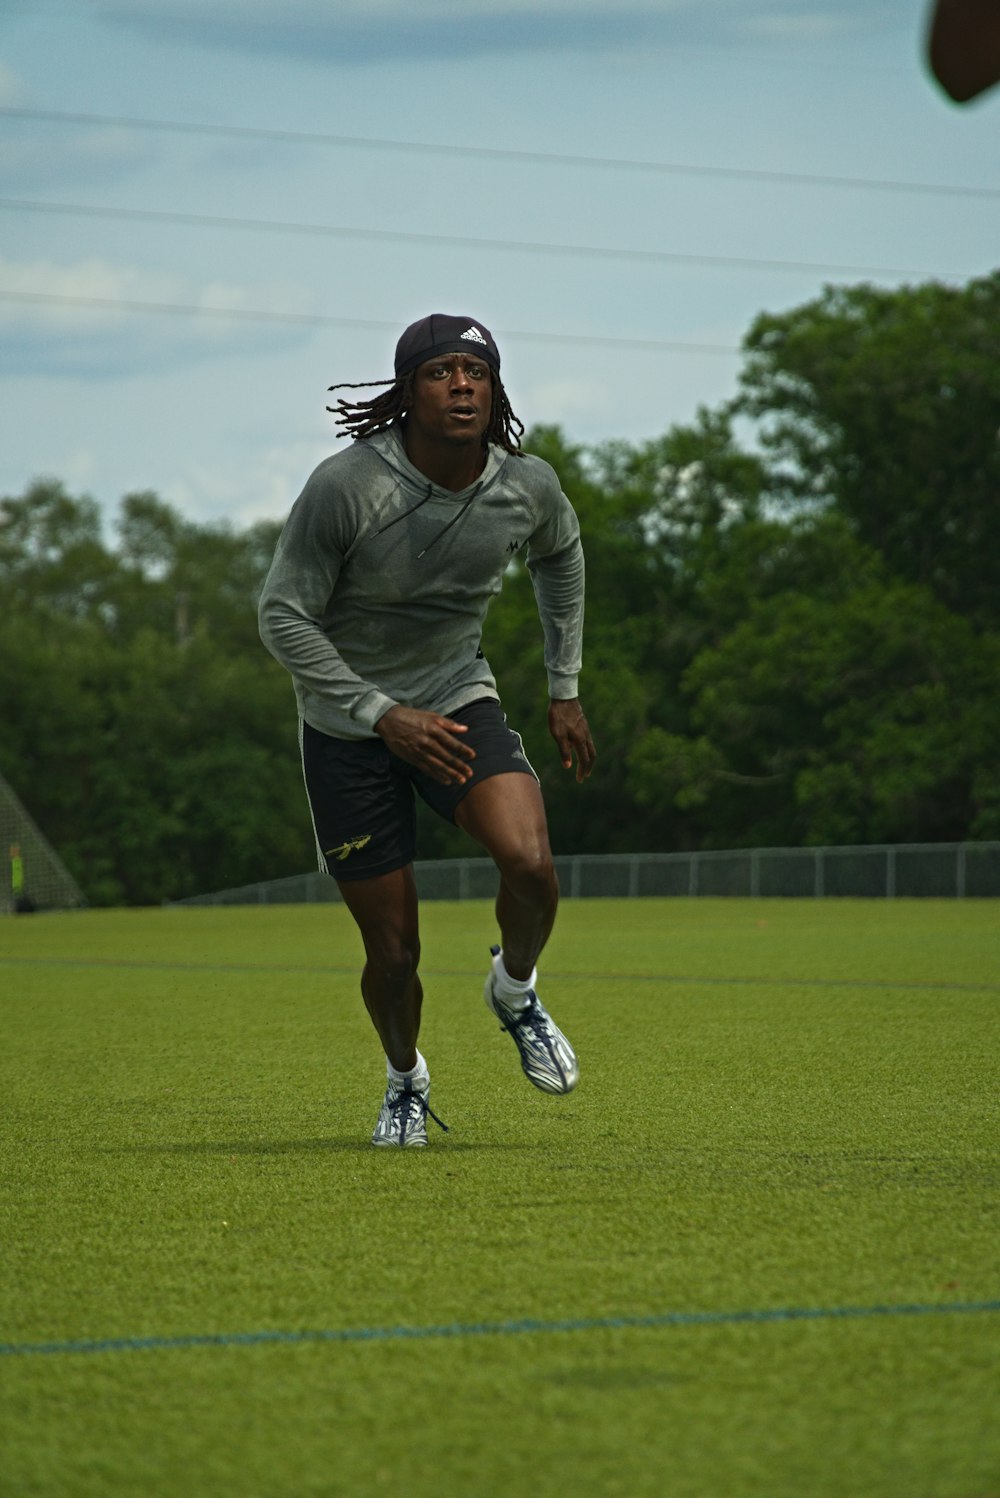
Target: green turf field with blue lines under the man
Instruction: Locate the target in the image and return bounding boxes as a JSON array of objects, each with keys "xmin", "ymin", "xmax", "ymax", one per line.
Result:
[{"xmin": 0, "ymin": 900, "xmax": 1000, "ymax": 1498}]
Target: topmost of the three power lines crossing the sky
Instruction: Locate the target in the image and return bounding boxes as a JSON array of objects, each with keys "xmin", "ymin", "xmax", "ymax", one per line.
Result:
[{"xmin": 0, "ymin": 106, "xmax": 1000, "ymax": 199}]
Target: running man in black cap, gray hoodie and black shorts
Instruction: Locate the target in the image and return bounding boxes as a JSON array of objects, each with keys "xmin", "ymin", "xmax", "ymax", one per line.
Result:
[{"xmin": 260, "ymin": 313, "xmax": 594, "ymax": 1147}]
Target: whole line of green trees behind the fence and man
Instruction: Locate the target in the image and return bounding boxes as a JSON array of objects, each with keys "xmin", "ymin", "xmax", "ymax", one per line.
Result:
[{"xmin": 0, "ymin": 273, "xmax": 1000, "ymax": 905}]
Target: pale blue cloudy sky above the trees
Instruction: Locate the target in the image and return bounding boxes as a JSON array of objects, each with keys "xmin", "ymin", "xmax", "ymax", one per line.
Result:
[{"xmin": 0, "ymin": 0, "xmax": 1000, "ymax": 526}]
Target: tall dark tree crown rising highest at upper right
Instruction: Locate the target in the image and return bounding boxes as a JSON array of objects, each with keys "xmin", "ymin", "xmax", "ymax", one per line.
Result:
[{"xmin": 738, "ymin": 271, "xmax": 1000, "ymax": 628}]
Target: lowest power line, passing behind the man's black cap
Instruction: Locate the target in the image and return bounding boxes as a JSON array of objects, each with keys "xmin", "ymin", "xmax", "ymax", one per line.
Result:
[{"xmin": 0, "ymin": 286, "xmax": 743, "ymax": 355}]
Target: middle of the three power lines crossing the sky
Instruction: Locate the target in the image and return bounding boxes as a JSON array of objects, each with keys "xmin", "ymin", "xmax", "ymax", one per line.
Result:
[{"xmin": 0, "ymin": 198, "xmax": 966, "ymax": 280}]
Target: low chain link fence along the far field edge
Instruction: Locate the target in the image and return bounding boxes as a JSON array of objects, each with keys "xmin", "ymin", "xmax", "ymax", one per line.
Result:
[{"xmin": 175, "ymin": 842, "xmax": 1000, "ymax": 905}]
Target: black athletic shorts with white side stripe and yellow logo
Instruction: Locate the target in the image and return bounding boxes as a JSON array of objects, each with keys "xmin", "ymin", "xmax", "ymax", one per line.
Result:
[{"xmin": 301, "ymin": 697, "xmax": 537, "ymax": 881}]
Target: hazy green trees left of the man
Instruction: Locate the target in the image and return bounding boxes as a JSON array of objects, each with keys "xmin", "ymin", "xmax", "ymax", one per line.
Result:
[{"xmin": 0, "ymin": 484, "xmax": 313, "ymax": 903}]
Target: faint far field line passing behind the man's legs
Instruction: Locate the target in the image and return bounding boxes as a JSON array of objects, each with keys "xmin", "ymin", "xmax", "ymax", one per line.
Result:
[{"xmin": 0, "ymin": 954, "xmax": 1000, "ymax": 993}]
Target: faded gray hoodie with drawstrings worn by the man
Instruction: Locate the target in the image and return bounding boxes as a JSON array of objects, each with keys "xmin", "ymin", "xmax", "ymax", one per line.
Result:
[{"xmin": 259, "ymin": 424, "xmax": 584, "ymax": 739}]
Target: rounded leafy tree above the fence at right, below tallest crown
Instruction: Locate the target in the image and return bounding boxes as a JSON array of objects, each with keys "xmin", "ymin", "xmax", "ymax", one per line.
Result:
[{"xmin": 632, "ymin": 581, "xmax": 1000, "ymax": 846}]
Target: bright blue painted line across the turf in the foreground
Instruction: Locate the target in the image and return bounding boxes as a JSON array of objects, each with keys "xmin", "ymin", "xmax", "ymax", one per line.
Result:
[{"xmin": 0, "ymin": 1300, "xmax": 1000, "ymax": 1357}]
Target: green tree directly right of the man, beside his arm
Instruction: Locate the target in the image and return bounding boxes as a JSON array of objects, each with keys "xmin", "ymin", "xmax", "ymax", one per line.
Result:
[{"xmin": 485, "ymin": 412, "xmax": 765, "ymax": 852}]
